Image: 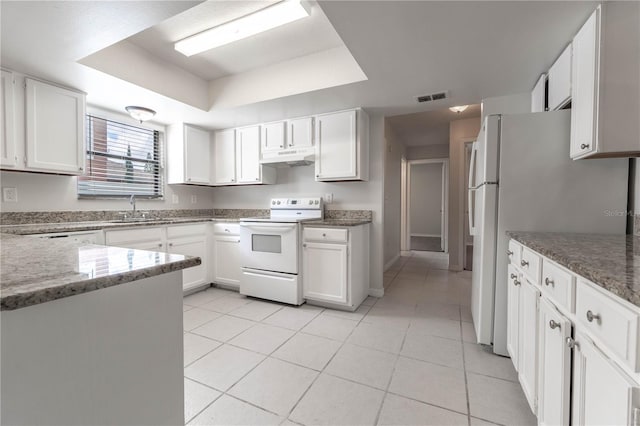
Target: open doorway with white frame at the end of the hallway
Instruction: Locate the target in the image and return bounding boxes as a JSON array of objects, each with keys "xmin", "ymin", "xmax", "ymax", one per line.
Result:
[{"xmin": 402, "ymin": 158, "xmax": 449, "ymax": 253}]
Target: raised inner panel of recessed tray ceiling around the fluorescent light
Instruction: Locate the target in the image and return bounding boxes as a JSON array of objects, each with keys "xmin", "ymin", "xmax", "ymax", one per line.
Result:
[{"xmin": 127, "ymin": 0, "xmax": 343, "ymax": 80}]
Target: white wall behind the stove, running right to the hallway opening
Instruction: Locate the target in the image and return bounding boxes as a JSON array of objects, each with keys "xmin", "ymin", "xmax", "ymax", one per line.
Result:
[{"xmin": 213, "ymin": 116, "xmax": 384, "ymax": 295}]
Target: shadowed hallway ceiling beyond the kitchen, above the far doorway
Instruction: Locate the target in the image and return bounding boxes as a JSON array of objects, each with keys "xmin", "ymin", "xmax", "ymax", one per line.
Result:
[{"xmin": 386, "ymin": 104, "xmax": 481, "ymax": 146}]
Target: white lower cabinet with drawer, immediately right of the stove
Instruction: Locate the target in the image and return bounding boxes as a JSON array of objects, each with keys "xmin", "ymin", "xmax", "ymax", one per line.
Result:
[{"xmin": 302, "ymin": 224, "xmax": 369, "ymax": 311}]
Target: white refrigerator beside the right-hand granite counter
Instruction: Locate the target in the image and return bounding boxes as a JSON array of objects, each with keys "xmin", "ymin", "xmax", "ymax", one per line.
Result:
[{"xmin": 468, "ymin": 110, "xmax": 628, "ymax": 355}]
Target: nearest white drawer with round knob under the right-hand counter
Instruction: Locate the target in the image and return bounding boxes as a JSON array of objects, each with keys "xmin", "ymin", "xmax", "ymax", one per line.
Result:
[{"xmin": 576, "ymin": 279, "xmax": 640, "ymax": 372}]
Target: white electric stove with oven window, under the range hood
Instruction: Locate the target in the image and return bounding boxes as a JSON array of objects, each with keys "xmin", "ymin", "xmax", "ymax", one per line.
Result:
[{"xmin": 240, "ymin": 198, "xmax": 324, "ymax": 305}]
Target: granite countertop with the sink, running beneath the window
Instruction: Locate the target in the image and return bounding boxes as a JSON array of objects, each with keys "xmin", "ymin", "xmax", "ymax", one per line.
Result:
[{"xmin": 0, "ymin": 217, "xmax": 240, "ymax": 235}]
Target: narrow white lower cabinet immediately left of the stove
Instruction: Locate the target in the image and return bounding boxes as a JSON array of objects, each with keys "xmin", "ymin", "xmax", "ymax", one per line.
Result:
[{"xmin": 212, "ymin": 223, "xmax": 242, "ymax": 289}]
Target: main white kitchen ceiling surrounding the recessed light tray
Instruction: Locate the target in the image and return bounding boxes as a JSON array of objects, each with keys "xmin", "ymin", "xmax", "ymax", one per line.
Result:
[{"xmin": 0, "ymin": 0, "xmax": 596, "ymax": 128}]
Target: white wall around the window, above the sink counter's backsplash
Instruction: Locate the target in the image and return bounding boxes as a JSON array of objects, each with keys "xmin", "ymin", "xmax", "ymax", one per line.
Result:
[{"xmin": 0, "ymin": 106, "xmax": 212, "ymax": 212}]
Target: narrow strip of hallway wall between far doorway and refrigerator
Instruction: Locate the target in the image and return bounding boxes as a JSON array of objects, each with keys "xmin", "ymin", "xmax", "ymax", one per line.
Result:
[{"xmin": 449, "ymin": 117, "xmax": 480, "ymax": 271}]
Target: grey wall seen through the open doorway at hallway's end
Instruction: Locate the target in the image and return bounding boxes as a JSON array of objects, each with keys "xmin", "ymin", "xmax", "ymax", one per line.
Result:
[{"xmin": 410, "ymin": 163, "xmax": 442, "ymax": 237}]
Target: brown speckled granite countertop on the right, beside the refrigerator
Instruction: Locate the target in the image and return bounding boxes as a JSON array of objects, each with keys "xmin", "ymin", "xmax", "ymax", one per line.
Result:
[{"xmin": 507, "ymin": 232, "xmax": 640, "ymax": 307}]
